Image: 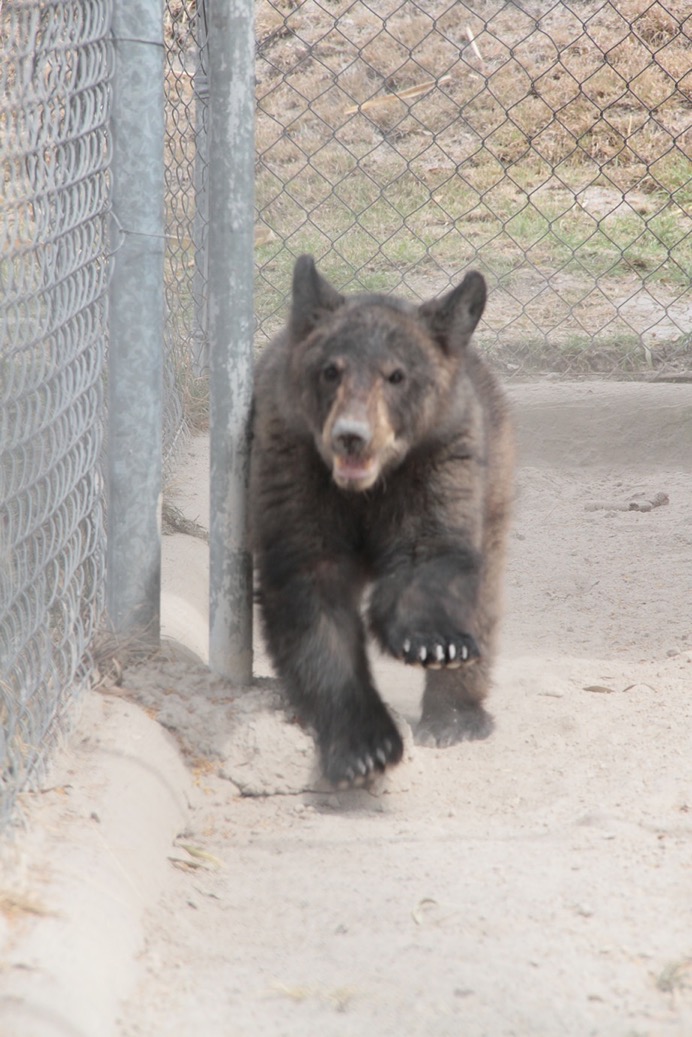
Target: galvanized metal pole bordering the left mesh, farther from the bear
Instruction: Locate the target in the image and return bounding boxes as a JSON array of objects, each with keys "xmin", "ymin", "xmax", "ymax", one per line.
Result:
[{"xmin": 107, "ymin": 0, "xmax": 164, "ymax": 644}]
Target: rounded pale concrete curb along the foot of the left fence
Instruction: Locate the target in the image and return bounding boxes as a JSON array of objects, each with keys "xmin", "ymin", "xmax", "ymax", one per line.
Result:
[{"xmin": 0, "ymin": 694, "xmax": 192, "ymax": 1037}]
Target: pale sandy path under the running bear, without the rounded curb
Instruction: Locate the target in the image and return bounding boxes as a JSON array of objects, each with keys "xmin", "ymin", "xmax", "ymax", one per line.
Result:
[{"xmin": 120, "ymin": 387, "xmax": 692, "ymax": 1037}]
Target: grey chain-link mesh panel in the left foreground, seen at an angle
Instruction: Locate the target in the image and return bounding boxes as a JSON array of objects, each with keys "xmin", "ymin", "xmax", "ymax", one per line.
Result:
[{"xmin": 0, "ymin": 0, "xmax": 111, "ymax": 826}]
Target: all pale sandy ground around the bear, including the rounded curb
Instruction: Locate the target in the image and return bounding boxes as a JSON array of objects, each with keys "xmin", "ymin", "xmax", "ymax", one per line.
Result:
[{"xmin": 0, "ymin": 385, "xmax": 692, "ymax": 1037}]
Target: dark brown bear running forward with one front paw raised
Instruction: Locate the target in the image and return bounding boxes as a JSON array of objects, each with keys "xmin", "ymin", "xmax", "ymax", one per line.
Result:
[{"xmin": 250, "ymin": 256, "xmax": 513, "ymax": 786}]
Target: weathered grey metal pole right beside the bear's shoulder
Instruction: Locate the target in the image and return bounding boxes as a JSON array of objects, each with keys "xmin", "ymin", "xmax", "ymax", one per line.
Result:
[{"xmin": 207, "ymin": 0, "xmax": 254, "ymax": 683}]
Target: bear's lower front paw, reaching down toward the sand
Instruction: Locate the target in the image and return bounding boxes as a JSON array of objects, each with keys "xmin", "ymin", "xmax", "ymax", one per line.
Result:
[{"xmin": 320, "ymin": 707, "xmax": 404, "ymax": 788}]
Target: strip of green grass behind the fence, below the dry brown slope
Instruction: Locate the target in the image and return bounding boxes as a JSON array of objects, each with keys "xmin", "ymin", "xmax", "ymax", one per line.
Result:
[{"xmin": 257, "ymin": 151, "xmax": 692, "ymax": 302}]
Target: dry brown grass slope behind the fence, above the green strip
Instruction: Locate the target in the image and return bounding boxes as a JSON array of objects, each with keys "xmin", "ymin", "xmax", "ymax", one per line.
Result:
[{"xmin": 257, "ymin": 0, "xmax": 692, "ymax": 184}]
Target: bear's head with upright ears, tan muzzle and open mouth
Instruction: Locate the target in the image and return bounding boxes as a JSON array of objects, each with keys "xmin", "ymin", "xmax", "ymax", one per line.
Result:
[{"xmin": 287, "ymin": 256, "xmax": 486, "ymax": 492}]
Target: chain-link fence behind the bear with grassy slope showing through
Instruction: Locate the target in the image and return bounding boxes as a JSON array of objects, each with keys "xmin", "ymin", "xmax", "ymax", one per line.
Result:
[{"xmin": 167, "ymin": 0, "xmax": 692, "ymax": 377}]
